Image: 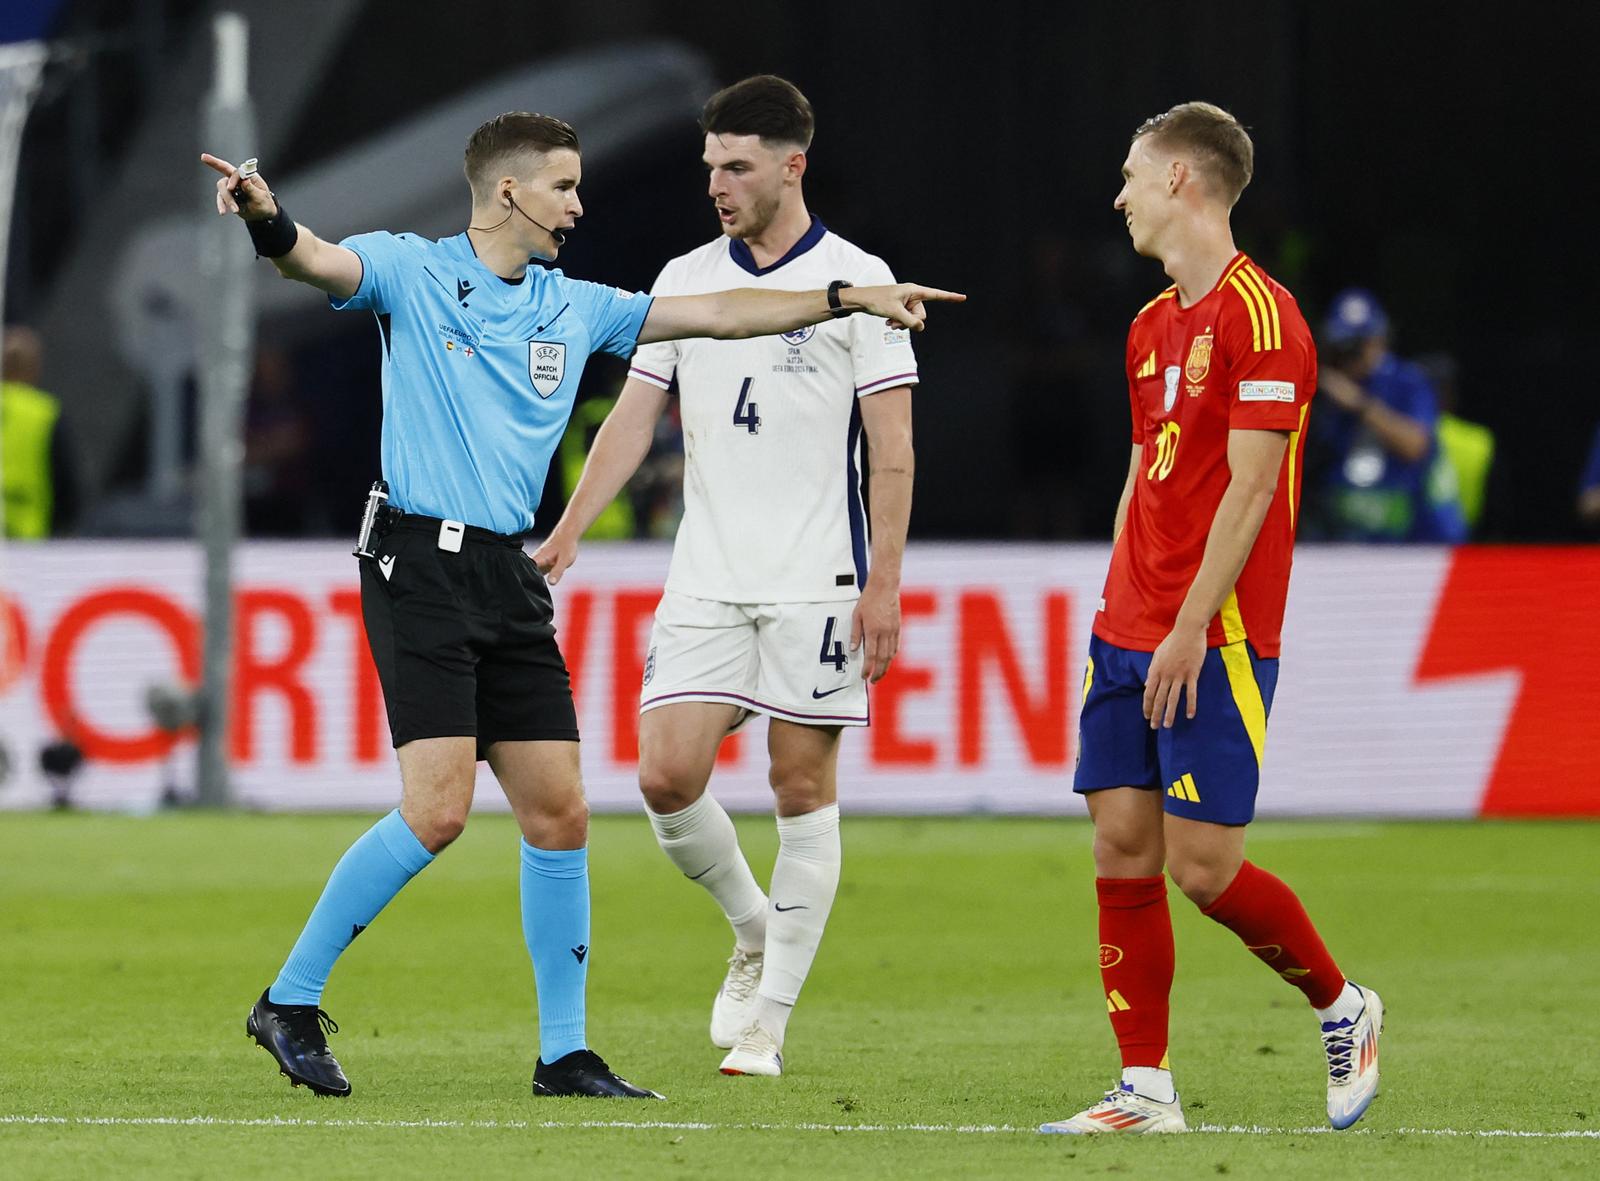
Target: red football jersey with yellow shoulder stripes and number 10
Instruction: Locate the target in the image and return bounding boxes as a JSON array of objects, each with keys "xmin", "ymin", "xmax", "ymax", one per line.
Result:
[{"xmin": 1094, "ymin": 254, "xmax": 1317, "ymax": 656}]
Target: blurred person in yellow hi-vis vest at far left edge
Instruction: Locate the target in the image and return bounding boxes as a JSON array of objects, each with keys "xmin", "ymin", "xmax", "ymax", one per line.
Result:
[{"xmin": 0, "ymin": 326, "xmax": 78, "ymax": 538}]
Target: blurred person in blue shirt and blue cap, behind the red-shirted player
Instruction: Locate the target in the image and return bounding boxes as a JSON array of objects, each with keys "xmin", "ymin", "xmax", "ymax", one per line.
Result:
[{"xmin": 1307, "ymin": 288, "xmax": 1467, "ymax": 542}]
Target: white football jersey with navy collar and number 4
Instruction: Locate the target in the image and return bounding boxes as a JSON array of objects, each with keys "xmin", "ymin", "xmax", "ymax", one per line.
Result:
[{"xmin": 629, "ymin": 218, "xmax": 917, "ymax": 603}]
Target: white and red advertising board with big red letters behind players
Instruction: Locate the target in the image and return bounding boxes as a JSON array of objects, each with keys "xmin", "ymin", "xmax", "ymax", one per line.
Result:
[{"xmin": 0, "ymin": 542, "xmax": 1600, "ymax": 816}]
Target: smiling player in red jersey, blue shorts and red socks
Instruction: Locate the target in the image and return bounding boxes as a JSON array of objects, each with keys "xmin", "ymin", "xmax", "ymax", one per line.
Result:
[{"xmin": 1042, "ymin": 102, "xmax": 1382, "ymax": 1133}]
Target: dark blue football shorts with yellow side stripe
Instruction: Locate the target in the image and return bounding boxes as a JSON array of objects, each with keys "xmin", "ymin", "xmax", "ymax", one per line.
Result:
[{"xmin": 1072, "ymin": 635, "xmax": 1278, "ymax": 824}]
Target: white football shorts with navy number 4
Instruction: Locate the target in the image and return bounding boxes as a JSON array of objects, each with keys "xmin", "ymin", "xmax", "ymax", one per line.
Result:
[{"xmin": 638, "ymin": 591, "xmax": 867, "ymax": 730}]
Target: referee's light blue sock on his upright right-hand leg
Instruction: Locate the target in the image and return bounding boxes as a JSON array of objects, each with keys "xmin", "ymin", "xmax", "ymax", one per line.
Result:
[{"xmin": 522, "ymin": 840, "xmax": 589, "ymax": 1063}]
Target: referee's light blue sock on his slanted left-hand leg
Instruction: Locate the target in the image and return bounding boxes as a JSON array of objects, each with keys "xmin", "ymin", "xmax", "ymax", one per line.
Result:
[{"xmin": 267, "ymin": 808, "xmax": 434, "ymax": 1005}]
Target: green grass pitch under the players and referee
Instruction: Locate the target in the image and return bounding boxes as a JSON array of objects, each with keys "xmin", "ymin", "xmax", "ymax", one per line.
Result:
[{"xmin": 0, "ymin": 815, "xmax": 1600, "ymax": 1181}]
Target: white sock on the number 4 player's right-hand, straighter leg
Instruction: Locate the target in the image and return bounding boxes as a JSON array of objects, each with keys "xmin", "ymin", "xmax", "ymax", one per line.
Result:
[{"xmin": 758, "ymin": 803, "xmax": 840, "ymax": 1005}]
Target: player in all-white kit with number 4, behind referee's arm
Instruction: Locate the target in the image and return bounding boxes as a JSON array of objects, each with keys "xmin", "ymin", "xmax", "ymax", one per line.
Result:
[{"xmin": 534, "ymin": 75, "xmax": 917, "ymax": 1075}]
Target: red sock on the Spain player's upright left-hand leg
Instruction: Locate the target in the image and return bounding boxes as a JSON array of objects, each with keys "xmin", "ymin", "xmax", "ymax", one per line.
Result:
[{"xmin": 1094, "ymin": 877, "xmax": 1173, "ymax": 1067}]
